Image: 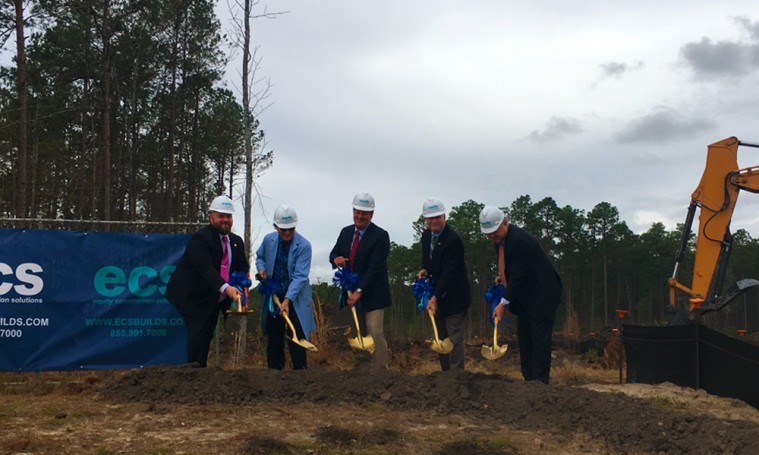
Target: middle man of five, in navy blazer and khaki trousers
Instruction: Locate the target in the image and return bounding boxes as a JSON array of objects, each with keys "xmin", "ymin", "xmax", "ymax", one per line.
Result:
[{"xmin": 329, "ymin": 193, "xmax": 391, "ymax": 371}]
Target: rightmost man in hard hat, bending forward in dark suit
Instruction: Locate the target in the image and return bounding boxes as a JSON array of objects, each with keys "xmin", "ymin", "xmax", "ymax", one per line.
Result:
[{"xmin": 480, "ymin": 206, "xmax": 561, "ymax": 384}]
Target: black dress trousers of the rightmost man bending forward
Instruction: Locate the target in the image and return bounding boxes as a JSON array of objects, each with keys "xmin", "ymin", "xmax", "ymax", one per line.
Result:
[{"xmin": 517, "ymin": 313, "xmax": 556, "ymax": 384}]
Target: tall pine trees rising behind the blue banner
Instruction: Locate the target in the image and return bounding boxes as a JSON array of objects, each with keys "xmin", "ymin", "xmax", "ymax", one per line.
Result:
[{"xmin": 0, "ymin": 0, "xmax": 272, "ymax": 233}]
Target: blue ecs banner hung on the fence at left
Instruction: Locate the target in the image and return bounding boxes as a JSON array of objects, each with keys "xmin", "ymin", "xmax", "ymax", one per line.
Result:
[{"xmin": 0, "ymin": 229, "xmax": 190, "ymax": 371}]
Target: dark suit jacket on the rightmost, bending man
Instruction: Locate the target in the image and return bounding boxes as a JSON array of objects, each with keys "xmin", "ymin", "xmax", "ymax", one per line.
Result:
[{"xmin": 495, "ymin": 224, "xmax": 561, "ymax": 319}]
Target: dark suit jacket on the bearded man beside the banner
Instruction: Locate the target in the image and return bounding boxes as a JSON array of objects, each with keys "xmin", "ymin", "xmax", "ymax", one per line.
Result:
[{"xmin": 166, "ymin": 224, "xmax": 250, "ymax": 318}]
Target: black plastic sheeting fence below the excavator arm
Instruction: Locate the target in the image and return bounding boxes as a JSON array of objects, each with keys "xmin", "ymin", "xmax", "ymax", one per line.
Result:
[{"xmin": 622, "ymin": 324, "xmax": 759, "ymax": 408}]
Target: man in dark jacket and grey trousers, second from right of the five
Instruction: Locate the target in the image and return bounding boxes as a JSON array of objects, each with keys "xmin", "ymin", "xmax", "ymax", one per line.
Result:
[{"xmin": 417, "ymin": 199, "xmax": 472, "ymax": 371}]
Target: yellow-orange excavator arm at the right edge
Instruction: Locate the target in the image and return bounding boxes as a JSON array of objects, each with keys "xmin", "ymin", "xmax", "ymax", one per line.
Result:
[{"xmin": 669, "ymin": 137, "xmax": 759, "ymax": 310}]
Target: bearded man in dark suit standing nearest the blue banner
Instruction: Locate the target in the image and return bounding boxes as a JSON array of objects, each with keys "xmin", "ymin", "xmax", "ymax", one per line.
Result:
[{"xmin": 166, "ymin": 196, "xmax": 250, "ymax": 367}]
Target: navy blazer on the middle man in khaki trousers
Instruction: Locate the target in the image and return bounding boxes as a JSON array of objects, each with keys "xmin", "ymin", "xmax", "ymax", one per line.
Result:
[{"xmin": 329, "ymin": 223, "xmax": 392, "ymax": 311}]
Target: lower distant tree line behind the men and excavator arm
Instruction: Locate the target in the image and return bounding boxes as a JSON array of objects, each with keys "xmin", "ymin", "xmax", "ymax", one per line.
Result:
[{"xmin": 315, "ymin": 195, "xmax": 759, "ymax": 340}]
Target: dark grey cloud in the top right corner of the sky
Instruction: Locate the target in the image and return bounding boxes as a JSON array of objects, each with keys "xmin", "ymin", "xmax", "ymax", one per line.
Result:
[{"xmin": 680, "ymin": 17, "xmax": 759, "ymax": 79}]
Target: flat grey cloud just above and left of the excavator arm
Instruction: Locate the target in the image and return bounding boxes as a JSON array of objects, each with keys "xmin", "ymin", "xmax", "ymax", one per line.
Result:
[{"xmin": 614, "ymin": 107, "xmax": 715, "ymax": 144}]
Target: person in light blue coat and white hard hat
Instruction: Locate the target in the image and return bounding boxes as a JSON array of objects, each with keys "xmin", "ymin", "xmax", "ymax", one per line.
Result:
[{"xmin": 256, "ymin": 205, "xmax": 316, "ymax": 370}]
